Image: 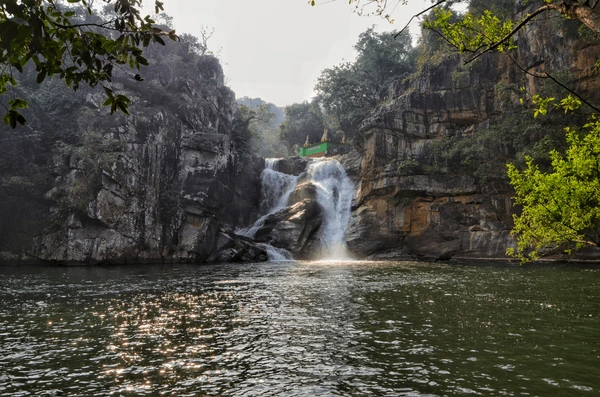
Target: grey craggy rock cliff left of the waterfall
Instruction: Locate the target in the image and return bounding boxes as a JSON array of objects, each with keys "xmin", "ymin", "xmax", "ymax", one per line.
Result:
[{"xmin": 0, "ymin": 54, "xmax": 267, "ymax": 264}]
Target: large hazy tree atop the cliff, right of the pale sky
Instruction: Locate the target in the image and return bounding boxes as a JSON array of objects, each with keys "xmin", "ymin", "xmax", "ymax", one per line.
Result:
[{"xmin": 315, "ymin": 28, "xmax": 415, "ymax": 136}]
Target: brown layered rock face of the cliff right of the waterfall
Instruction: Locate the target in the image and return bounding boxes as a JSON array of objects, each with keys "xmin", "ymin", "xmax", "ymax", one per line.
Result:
[{"xmin": 344, "ymin": 6, "xmax": 600, "ymax": 259}]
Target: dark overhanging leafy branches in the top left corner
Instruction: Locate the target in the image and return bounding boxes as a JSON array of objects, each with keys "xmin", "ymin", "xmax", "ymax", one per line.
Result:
[{"xmin": 0, "ymin": 0, "xmax": 177, "ymax": 128}]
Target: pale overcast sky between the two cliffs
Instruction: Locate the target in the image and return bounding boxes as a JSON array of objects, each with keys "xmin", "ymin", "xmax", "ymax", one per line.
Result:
[{"xmin": 147, "ymin": 0, "xmax": 431, "ymax": 106}]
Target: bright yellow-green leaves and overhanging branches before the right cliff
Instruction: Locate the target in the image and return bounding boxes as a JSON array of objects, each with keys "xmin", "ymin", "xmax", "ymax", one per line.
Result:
[{"xmin": 426, "ymin": 1, "xmax": 600, "ymax": 261}]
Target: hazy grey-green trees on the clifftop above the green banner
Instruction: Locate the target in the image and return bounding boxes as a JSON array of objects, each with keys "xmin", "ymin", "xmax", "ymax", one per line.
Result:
[{"xmin": 280, "ymin": 28, "xmax": 415, "ymax": 154}]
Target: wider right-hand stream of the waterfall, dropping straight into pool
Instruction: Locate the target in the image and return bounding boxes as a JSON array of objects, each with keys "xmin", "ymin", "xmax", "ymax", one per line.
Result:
[{"xmin": 307, "ymin": 159, "xmax": 354, "ymax": 260}]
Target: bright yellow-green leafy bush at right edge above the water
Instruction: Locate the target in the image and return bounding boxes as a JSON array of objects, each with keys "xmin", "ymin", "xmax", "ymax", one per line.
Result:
[{"xmin": 508, "ymin": 120, "xmax": 600, "ymax": 261}]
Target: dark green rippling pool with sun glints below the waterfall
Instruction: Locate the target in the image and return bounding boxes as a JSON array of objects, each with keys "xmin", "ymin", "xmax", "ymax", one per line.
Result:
[{"xmin": 0, "ymin": 262, "xmax": 600, "ymax": 396}]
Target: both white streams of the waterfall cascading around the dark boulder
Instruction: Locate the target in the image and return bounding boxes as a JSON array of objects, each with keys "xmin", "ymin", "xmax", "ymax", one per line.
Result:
[{"xmin": 236, "ymin": 159, "xmax": 354, "ymax": 261}]
